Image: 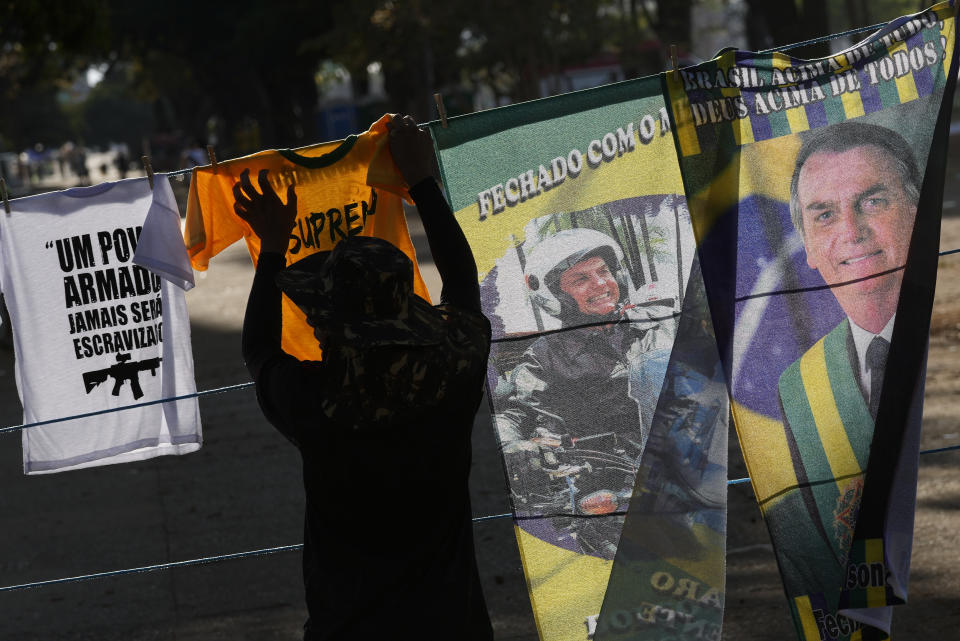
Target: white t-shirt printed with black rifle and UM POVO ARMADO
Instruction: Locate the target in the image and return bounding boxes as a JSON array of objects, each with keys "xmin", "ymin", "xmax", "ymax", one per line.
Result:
[{"xmin": 0, "ymin": 175, "xmax": 202, "ymax": 474}]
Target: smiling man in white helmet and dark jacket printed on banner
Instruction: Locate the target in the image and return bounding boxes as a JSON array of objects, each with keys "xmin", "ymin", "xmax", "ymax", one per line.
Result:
[{"xmin": 495, "ymin": 228, "xmax": 676, "ymax": 558}]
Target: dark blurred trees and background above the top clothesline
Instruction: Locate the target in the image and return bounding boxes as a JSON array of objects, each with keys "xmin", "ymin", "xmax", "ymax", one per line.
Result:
[{"xmin": 0, "ymin": 0, "xmax": 928, "ymax": 171}]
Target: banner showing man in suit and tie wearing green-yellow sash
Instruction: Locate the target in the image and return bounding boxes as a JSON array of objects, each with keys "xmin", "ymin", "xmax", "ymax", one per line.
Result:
[{"xmin": 664, "ymin": 2, "xmax": 957, "ymax": 641}]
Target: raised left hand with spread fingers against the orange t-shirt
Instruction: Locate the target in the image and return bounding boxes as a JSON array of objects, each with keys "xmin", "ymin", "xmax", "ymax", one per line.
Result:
[{"xmin": 233, "ymin": 169, "xmax": 297, "ymax": 254}]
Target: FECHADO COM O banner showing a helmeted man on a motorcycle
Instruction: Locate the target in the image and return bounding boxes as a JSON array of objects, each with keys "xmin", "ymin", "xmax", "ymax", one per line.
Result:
[{"xmin": 432, "ymin": 78, "xmax": 727, "ymax": 641}]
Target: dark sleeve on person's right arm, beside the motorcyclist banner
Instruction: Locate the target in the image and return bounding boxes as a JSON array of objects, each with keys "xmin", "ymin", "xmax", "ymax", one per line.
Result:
[{"xmin": 410, "ymin": 177, "xmax": 480, "ymax": 312}]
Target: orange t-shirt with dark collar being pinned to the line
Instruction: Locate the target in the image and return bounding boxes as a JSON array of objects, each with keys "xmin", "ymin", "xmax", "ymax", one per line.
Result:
[{"xmin": 184, "ymin": 115, "xmax": 430, "ymax": 360}]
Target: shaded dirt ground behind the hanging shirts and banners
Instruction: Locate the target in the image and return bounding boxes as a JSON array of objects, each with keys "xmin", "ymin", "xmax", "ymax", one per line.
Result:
[{"xmin": 0, "ymin": 166, "xmax": 960, "ymax": 641}]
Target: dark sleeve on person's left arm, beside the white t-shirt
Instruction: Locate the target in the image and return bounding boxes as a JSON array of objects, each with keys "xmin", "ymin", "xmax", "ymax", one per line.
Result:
[{"xmin": 241, "ymin": 252, "xmax": 311, "ymax": 447}]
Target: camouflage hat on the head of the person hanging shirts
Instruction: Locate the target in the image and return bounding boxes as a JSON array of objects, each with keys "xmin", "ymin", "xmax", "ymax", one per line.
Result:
[{"xmin": 277, "ymin": 236, "xmax": 442, "ymax": 345}]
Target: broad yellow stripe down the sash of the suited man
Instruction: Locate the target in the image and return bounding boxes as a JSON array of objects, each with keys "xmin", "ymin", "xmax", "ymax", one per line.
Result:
[{"xmin": 800, "ymin": 339, "xmax": 862, "ymax": 494}]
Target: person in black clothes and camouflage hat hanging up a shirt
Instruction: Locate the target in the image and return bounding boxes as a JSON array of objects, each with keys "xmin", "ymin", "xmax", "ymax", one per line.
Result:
[{"xmin": 234, "ymin": 116, "xmax": 493, "ymax": 641}]
